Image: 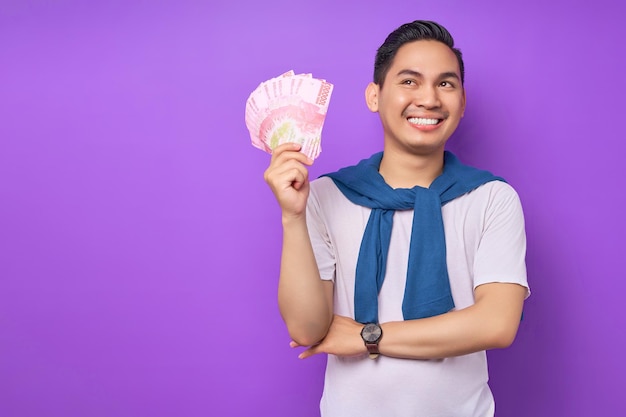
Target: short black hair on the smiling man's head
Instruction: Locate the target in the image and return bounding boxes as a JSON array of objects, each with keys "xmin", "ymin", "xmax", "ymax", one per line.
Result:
[{"xmin": 374, "ymin": 20, "xmax": 465, "ymax": 87}]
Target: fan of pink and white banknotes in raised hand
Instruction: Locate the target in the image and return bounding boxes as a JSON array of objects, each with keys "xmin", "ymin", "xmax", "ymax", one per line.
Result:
[{"xmin": 246, "ymin": 71, "xmax": 333, "ymax": 159}]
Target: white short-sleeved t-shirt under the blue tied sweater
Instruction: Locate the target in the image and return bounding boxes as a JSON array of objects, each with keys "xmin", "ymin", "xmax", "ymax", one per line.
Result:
[{"xmin": 307, "ymin": 177, "xmax": 528, "ymax": 417}]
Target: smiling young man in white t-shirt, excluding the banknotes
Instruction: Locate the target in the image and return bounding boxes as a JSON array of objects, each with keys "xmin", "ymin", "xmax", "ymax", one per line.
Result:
[{"xmin": 265, "ymin": 21, "xmax": 529, "ymax": 417}]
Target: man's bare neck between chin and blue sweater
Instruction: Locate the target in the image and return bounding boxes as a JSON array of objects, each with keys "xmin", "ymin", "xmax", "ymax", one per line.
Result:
[{"xmin": 379, "ymin": 149, "xmax": 443, "ymax": 188}]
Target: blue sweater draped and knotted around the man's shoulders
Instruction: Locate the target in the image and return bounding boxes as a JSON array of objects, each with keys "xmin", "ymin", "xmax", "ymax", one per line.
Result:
[{"xmin": 325, "ymin": 151, "xmax": 504, "ymax": 323}]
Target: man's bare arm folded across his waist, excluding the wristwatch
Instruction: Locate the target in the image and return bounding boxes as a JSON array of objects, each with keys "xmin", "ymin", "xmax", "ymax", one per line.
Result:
[{"xmin": 292, "ymin": 283, "xmax": 527, "ymax": 359}]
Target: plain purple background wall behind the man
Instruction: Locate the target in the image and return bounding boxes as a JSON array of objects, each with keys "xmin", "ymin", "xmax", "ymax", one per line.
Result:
[{"xmin": 0, "ymin": 0, "xmax": 626, "ymax": 417}]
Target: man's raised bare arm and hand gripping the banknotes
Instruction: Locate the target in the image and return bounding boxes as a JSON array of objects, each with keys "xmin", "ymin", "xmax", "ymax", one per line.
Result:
[{"xmin": 265, "ymin": 144, "xmax": 333, "ymax": 346}]
